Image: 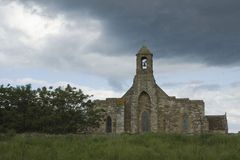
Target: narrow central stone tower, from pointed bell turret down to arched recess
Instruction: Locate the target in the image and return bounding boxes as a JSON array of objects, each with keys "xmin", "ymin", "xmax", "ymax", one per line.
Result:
[{"xmin": 131, "ymin": 46, "xmax": 156, "ymax": 132}]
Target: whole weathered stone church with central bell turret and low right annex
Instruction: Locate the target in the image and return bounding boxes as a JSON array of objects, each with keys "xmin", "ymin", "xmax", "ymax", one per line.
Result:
[{"xmin": 96, "ymin": 47, "xmax": 228, "ymax": 133}]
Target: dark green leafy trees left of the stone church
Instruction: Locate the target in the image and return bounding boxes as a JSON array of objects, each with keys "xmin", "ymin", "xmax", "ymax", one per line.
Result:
[{"xmin": 0, "ymin": 85, "xmax": 103, "ymax": 133}]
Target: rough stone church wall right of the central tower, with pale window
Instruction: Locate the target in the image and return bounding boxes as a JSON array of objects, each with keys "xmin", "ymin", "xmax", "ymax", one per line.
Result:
[{"xmin": 158, "ymin": 97, "xmax": 204, "ymax": 133}]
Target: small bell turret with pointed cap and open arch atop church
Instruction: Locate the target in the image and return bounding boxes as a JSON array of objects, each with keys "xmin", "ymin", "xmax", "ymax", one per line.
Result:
[{"xmin": 136, "ymin": 46, "xmax": 153, "ymax": 75}]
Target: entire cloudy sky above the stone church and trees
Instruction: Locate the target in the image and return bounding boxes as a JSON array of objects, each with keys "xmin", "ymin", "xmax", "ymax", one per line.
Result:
[{"xmin": 0, "ymin": 0, "xmax": 240, "ymax": 132}]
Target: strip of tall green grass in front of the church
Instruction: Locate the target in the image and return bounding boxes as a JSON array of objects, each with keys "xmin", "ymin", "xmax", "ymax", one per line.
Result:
[{"xmin": 0, "ymin": 134, "xmax": 240, "ymax": 160}]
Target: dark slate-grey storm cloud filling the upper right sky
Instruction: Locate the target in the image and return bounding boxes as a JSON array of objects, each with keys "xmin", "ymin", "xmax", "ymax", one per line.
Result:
[{"xmin": 17, "ymin": 0, "xmax": 240, "ymax": 65}]
